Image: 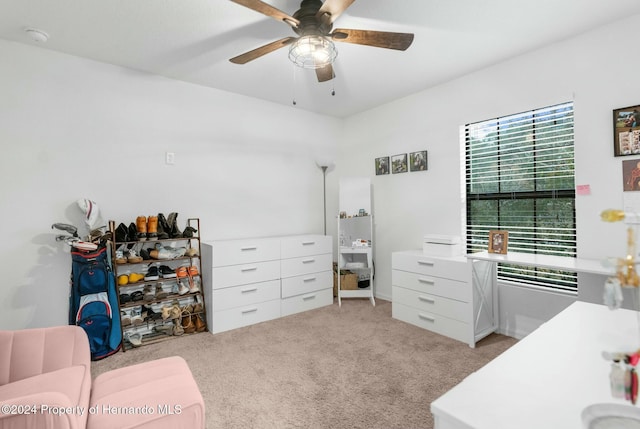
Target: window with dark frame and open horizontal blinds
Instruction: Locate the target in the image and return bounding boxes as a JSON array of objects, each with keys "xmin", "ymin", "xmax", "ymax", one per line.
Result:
[{"xmin": 463, "ymin": 103, "xmax": 577, "ymax": 294}]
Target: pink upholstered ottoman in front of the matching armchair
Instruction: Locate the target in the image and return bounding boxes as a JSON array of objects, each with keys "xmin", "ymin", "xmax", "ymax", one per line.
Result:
[{"xmin": 87, "ymin": 356, "xmax": 205, "ymax": 429}]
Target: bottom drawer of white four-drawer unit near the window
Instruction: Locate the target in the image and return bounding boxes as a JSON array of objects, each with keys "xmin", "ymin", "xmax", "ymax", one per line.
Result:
[{"xmin": 391, "ymin": 301, "xmax": 471, "ymax": 343}]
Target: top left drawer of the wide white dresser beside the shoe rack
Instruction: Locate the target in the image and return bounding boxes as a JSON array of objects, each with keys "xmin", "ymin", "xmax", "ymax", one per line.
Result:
[{"xmin": 210, "ymin": 238, "xmax": 280, "ymax": 267}]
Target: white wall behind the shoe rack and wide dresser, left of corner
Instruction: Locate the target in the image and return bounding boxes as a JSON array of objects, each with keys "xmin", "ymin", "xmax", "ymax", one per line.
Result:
[{"xmin": 0, "ymin": 41, "xmax": 343, "ymax": 329}]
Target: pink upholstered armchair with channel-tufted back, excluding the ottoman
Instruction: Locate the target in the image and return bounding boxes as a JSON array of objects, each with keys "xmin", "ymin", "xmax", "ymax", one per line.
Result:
[{"xmin": 0, "ymin": 326, "xmax": 91, "ymax": 429}]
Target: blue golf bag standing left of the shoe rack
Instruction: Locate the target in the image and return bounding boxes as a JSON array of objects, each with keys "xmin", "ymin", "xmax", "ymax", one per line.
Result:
[{"xmin": 69, "ymin": 245, "xmax": 122, "ymax": 360}]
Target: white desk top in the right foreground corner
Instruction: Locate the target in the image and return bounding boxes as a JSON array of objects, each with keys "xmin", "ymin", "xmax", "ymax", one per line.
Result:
[{"xmin": 431, "ymin": 301, "xmax": 640, "ymax": 429}]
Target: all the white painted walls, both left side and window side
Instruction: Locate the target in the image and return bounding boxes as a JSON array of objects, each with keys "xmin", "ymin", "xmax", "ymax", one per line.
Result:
[{"xmin": 0, "ymin": 16, "xmax": 640, "ymax": 336}]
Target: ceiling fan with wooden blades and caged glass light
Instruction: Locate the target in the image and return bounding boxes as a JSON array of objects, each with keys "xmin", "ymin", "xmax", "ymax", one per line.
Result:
[{"xmin": 229, "ymin": 0, "xmax": 413, "ymax": 82}]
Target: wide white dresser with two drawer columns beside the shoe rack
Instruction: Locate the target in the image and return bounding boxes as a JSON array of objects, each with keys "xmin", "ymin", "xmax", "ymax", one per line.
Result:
[{"xmin": 203, "ymin": 235, "xmax": 333, "ymax": 333}]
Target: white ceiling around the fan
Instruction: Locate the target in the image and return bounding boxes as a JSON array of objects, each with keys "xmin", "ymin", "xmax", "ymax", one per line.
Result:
[{"xmin": 0, "ymin": 0, "xmax": 640, "ymax": 117}]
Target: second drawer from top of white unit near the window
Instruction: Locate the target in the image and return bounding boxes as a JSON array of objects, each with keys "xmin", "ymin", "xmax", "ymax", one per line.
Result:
[{"xmin": 391, "ymin": 269, "xmax": 471, "ymax": 302}]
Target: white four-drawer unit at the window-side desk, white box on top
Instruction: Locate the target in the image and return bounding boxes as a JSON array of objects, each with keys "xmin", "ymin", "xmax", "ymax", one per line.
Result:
[{"xmin": 391, "ymin": 250, "xmax": 497, "ymax": 347}]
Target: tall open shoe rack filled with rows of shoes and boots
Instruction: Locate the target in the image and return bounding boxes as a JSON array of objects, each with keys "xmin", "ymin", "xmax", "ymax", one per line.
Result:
[{"xmin": 109, "ymin": 213, "xmax": 208, "ymax": 351}]
